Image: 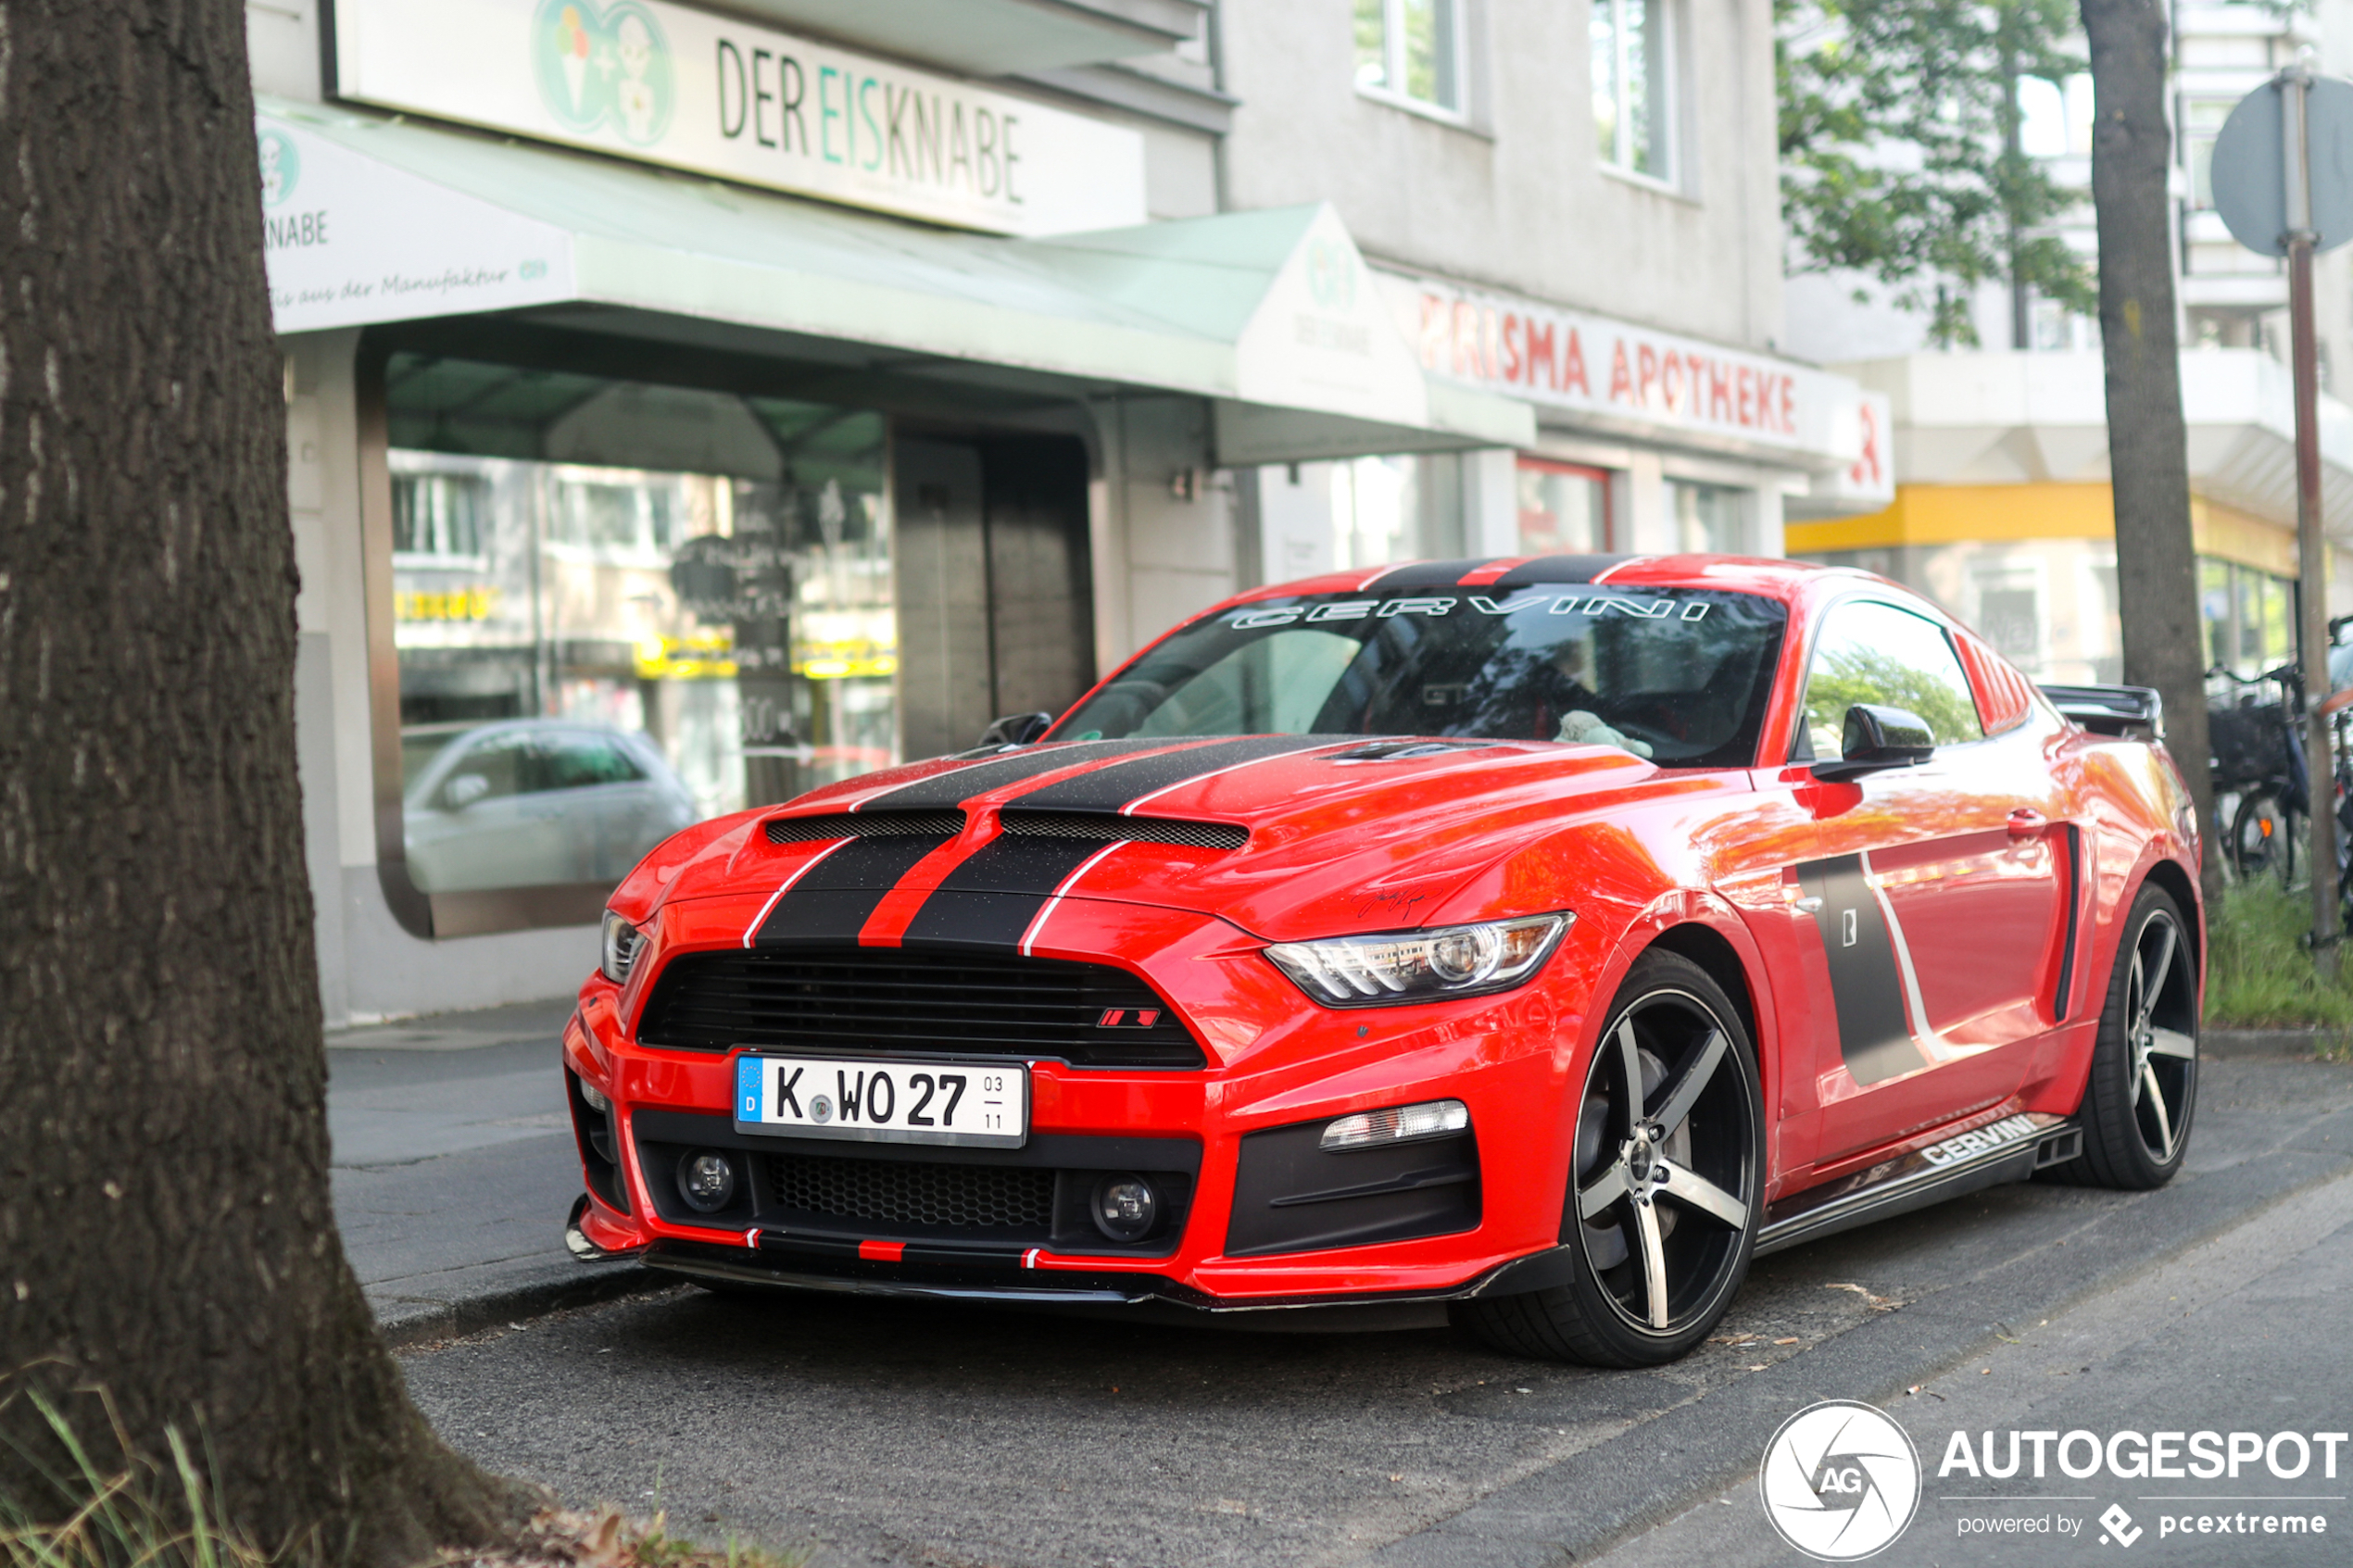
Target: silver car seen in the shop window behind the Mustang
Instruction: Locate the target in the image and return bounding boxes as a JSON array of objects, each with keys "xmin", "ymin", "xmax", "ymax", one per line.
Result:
[{"xmin": 402, "ymin": 720, "xmax": 701, "ymax": 894}]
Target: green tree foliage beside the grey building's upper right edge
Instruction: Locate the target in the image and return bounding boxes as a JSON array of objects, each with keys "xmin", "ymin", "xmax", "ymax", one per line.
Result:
[{"xmin": 1774, "ymin": 0, "xmax": 2099, "ymax": 348}]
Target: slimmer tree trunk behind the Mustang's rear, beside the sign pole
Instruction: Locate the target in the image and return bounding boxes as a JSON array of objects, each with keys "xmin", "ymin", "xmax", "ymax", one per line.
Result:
[{"xmin": 2082, "ymin": 0, "xmax": 2221, "ymax": 900}]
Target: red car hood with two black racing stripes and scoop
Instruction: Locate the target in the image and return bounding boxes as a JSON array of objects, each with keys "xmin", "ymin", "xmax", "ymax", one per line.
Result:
[{"xmin": 668, "ymin": 735, "xmax": 1746, "ymax": 940}]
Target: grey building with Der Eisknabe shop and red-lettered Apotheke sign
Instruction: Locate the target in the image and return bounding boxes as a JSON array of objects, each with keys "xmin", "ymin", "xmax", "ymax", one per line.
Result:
[{"xmin": 247, "ymin": 0, "xmax": 1892, "ymax": 1021}]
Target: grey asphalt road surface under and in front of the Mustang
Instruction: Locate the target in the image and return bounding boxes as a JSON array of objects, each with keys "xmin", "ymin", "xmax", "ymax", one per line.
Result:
[{"xmin": 405, "ymin": 1060, "xmax": 2353, "ymax": 1568}]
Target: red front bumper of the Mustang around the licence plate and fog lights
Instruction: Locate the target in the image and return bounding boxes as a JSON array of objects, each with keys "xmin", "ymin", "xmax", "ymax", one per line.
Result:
[{"xmin": 565, "ymin": 908, "xmax": 1586, "ymax": 1311}]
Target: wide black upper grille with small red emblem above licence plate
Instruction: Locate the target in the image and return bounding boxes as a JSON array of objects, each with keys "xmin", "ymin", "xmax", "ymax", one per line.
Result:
[{"xmin": 637, "ymin": 947, "xmax": 1207, "ymax": 1067}]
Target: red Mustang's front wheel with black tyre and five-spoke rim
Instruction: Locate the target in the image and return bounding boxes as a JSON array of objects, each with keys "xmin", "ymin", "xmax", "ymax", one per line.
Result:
[{"xmin": 1454, "ymin": 949, "xmax": 1765, "ymax": 1366}]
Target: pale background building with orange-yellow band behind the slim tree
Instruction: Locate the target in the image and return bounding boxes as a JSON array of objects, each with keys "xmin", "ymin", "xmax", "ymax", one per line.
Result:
[{"xmin": 1786, "ymin": 0, "xmax": 2353, "ymax": 682}]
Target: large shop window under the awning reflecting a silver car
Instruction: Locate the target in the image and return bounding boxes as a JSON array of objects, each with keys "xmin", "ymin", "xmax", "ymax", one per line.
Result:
[{"xmin": 386, "ymin": 355, "xmax": 899, "ymax": 894}]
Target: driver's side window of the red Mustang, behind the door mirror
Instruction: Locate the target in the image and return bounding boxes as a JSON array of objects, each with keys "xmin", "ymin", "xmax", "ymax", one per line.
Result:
[{"xmin": 1791, "ymin": 602, "xmax": 1986, "ymax": 761}]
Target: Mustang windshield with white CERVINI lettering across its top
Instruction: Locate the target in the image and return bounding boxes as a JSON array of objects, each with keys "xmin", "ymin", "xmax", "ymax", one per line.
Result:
[{"xmin": 1054, "ymin": 585, "xmax": 1786, "ymax": 769}]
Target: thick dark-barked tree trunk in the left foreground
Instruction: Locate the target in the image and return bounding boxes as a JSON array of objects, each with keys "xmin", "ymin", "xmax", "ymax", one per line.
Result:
[{"xmin": 0, "ymin": 0, "xmax": 524, "ymax": 1563}]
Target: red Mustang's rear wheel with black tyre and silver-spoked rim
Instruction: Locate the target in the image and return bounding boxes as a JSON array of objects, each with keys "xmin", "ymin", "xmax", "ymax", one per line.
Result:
[{"xmin": 2059, "ymin": 884, "xmax": 2197, "ymax": 1192}]
